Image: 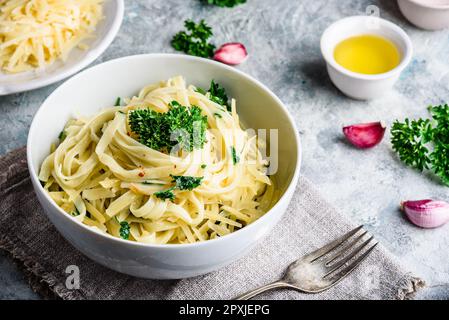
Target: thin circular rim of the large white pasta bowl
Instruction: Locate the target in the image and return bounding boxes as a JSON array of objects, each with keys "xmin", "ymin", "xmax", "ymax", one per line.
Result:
[{"xmin": 27, "ymin": 53, "xmax": 302, "ymax": 249}]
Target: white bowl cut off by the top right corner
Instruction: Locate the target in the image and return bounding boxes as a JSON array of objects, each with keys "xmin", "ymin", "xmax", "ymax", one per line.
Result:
[{"xmin": 398, "ymin": 0, "xmax": 449, "ymax": 30}]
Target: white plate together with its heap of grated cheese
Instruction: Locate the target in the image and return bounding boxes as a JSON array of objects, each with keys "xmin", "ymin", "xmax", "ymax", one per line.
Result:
[{"xmin": 0, "ymin": 0, "xmax": 124, "ymax": 96}]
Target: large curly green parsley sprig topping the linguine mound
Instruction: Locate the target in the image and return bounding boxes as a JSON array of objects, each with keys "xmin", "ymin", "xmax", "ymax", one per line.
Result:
[{"xmin": 129, "ymin": 101, "xmax": 207, "ymax": 152}]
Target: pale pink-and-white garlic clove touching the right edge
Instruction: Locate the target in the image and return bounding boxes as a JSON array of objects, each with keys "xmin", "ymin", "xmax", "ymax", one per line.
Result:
[{"xmin": 401, "ymin": 199, "xmax": 449, "ymax": 228}]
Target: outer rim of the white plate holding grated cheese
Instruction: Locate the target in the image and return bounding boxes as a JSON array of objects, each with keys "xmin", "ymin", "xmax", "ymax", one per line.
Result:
[{"xmin": 0, "ymin": 0, "xmax": 125, "ymax": 96}]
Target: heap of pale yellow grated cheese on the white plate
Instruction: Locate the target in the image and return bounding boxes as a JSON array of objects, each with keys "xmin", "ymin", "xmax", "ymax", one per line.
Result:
[{"xmin": 0, "ymin": 0, "xmax": 104, "ymax": 73}]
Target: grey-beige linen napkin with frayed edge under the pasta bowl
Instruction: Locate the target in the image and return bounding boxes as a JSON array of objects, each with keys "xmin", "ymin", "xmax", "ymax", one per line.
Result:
[{"xmin": 0, "ymin": 148, "xmax": 423, "ymax": 299}]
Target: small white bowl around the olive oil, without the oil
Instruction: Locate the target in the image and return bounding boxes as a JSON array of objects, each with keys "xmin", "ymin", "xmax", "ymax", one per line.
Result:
[{"xmin": 321, "ymin": 16, "xmax": 413, "ymax": 100}]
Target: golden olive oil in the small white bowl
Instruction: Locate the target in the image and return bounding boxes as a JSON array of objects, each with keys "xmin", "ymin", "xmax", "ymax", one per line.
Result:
[{"xmin": 334, "ymin": 34, "xmax": 401, "ymax": 74}]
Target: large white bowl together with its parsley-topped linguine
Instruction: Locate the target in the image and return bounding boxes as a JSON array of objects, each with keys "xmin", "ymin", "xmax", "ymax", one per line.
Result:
[{"xmin": 27, "ymin": 54, "xmax": 301, "ymax": 279}]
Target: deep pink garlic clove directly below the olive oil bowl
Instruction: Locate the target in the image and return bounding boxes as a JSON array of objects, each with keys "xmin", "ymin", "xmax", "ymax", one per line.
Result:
[{"xmin": 343, "ymin": 122, "xmax": 386, "ymax": 149}]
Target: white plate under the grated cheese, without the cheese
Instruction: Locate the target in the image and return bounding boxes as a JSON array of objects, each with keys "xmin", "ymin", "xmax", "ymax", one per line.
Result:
[{"xmin": 0, "ymin": 0, "xmax": 125, "ymax": 96}]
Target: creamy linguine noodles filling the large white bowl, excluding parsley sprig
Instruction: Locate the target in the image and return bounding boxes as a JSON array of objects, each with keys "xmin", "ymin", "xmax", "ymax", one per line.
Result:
[{"xmin": 39, "ymin": 77, "xmax": 276, "ymax": 244}]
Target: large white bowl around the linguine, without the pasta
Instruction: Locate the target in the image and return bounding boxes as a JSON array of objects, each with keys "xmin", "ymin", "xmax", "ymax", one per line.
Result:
[{"xmin": 27, "ymin": 54, "xmax": 301, "ymax": 279}]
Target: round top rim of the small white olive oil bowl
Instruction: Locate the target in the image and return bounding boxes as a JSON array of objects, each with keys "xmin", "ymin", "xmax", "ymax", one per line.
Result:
[{"xmin": 320, "ymin": 15, "xmax": 413, "ymax": 80}]
